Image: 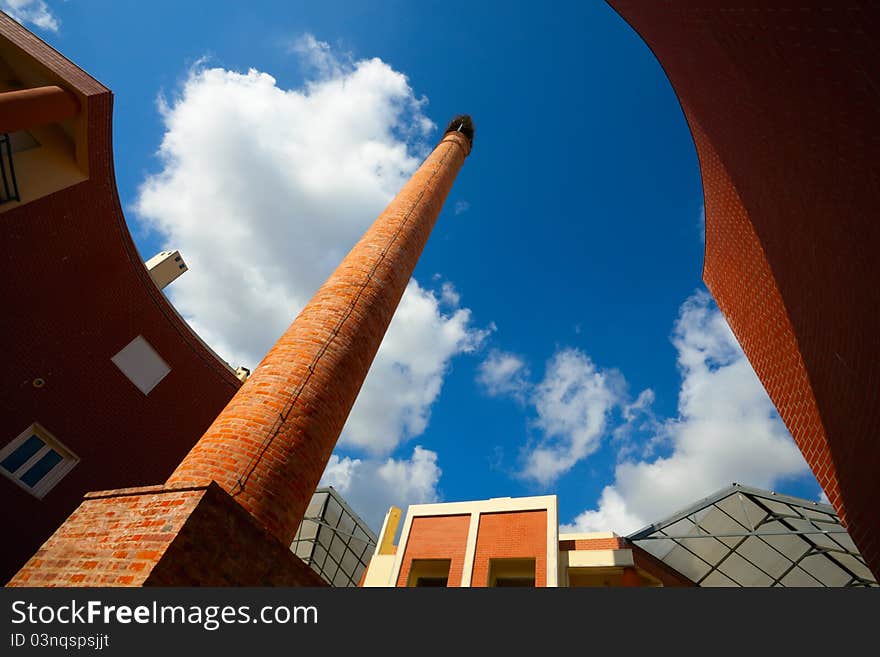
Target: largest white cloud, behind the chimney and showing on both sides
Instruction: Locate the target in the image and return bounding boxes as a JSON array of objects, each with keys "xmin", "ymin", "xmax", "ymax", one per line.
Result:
[{"xmin": 136, "ymin": 36, "xmax": 485, "ymax": 452}]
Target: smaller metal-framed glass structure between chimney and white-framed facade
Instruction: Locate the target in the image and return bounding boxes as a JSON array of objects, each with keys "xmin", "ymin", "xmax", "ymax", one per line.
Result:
[{"xmin": 290, "ymin": 486, "xmax": 377, "ymax": 587}]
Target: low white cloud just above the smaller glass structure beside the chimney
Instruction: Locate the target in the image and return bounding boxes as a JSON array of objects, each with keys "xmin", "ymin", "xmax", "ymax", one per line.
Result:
[{"xmin": 320, "ymin": 445, "xmax": 442, "ymax": 532}]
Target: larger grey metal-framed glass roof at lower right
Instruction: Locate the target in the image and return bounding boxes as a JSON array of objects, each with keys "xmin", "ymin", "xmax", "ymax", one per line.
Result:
[{"xmin": 627, "ymin": 484, "xmax": 877, "ymax": 587}]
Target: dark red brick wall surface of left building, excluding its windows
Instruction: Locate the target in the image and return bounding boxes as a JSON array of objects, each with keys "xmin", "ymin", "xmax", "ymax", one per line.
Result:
[{"xmin": 0, "ymin": 14, "xmax": 241, "ymax": 582}]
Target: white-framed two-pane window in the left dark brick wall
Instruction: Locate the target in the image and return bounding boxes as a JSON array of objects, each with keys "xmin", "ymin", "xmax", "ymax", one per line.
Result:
[{"xmin": 0, "ymin": 422, "xmax": 79, "ymax": 498}]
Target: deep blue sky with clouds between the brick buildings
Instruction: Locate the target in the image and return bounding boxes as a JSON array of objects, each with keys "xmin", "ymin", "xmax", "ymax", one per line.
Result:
[{"xmin": 10, "ymin": 0, "xmax": 820, "ymax": 533}]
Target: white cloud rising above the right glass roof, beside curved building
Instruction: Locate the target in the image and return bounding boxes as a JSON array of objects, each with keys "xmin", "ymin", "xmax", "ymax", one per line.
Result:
[{"xmin": 564, "ymin": 292, "xmax": 808, "ymax": 534}]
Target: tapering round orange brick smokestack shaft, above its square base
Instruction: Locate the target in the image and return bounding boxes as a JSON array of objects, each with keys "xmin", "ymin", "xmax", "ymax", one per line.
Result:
[{"xmin": 166, "ymin": 116, "xmax": 474, "ymax": 544}]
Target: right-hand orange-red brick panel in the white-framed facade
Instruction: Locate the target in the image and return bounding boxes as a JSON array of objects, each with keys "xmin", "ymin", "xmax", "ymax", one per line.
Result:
[{"xmin": 471, "ymin": 510, "xmax": 547, "ymax": 587}]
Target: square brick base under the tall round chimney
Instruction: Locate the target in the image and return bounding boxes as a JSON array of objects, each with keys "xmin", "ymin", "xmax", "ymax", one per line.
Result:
[{"xmin": 7, "ymin": 482, "xmax": 326, "ymax": 586}]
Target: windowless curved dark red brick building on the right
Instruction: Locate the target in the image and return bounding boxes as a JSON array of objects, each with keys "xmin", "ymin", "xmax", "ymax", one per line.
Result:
[{"xmin": 610, "ymin": 0, "xmax": 880, "ymax": 575}]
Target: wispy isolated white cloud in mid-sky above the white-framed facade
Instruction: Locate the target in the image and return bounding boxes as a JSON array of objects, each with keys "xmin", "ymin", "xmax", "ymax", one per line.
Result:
[{"xmin": 522, "ymin": 349, "xmax": 625, "ymax": 486}]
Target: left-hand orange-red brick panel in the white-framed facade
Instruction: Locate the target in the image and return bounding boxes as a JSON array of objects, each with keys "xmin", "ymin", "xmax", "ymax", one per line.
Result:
[{"xmin": 397, "ymin": 514, "xmax": 471, "ymax": 587}]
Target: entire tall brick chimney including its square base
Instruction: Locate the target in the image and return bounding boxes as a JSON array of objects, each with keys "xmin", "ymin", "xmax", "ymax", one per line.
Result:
[{"xmin": 9, "ymin": 116, "xmax": 473, "ymax": 586}]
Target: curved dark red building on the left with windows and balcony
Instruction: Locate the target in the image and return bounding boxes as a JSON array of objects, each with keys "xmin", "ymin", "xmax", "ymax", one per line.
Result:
[{"xmin": 0, "ymin": 13, "xmax": 241, "ymax": 582}]
